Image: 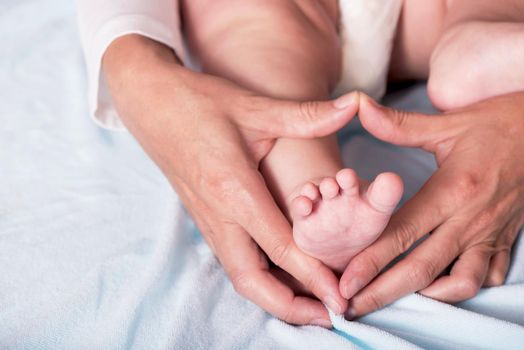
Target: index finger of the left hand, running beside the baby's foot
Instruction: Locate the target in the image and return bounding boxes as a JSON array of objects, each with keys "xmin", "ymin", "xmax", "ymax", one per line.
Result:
[{"xmin": 232, "ymin": 171, "xmax": 347, "ymax": 314}]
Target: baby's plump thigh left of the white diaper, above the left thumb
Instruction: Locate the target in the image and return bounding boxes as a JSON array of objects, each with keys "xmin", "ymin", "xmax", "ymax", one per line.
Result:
[{"xmin": 183, "ymin": 0, "xmax": 340, "ymax": 99}]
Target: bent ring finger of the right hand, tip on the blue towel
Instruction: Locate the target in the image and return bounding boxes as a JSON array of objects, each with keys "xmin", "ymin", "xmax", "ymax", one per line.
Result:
[{"xmin": 420, "ymin": 246, "xmax": 492, "ymax": 303}]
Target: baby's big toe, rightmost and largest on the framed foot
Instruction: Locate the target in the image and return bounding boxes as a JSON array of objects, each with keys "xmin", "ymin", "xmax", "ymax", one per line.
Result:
[{"xmin": 366, "ymin": 173, "xmax": 404, "ymax": 213}]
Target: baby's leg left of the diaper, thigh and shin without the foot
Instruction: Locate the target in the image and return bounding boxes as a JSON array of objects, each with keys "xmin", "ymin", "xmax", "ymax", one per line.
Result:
[{"xmin": 184, "ymin": 0, "xmax": 341, "ymax": 211}]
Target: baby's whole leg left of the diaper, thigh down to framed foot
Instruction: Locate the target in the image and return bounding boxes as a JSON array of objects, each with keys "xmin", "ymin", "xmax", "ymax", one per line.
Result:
[{"xmin": 182, "ymin": 0, "xmax": 403, "ymax": 273}]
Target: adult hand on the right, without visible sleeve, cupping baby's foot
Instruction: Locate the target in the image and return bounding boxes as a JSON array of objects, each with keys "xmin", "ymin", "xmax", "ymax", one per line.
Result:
[{"xmin": 340, "ymin": 92, "xmax": 524, "ymax": 318}]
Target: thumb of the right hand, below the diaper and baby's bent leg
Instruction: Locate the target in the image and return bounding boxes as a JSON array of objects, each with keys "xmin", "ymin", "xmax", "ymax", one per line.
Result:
[{"xmin": 358, "ymin": 94, "xmax": 449, "ymax": 152}]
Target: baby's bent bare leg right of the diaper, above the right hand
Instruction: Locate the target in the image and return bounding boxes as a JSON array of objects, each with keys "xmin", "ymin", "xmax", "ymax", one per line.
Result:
[{"xmin": 391, "ymin": 0, "xmax": 524, "ymax": 110}]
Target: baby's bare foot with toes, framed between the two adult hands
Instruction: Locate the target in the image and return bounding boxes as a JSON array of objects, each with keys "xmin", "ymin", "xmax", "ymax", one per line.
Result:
[{"xmin": 290, "ymin": 169, "xmax": 403, "ymax": 272}]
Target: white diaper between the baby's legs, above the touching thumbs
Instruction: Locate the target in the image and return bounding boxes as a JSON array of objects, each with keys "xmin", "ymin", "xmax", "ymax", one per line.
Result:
[{"xmin": 334, "ymin": 0, "xmax": 402, "ymax": 99}]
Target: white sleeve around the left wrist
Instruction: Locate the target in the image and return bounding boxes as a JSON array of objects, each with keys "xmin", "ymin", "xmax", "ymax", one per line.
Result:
[{"xmin": 77, "ymin": 0, "xmax": 187, "ymax": 129}]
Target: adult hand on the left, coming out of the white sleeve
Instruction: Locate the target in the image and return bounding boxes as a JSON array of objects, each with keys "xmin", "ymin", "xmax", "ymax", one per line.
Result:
[{"xmin": 104, "ymin": 36, "xmax": 358, "ymax": 327}]
